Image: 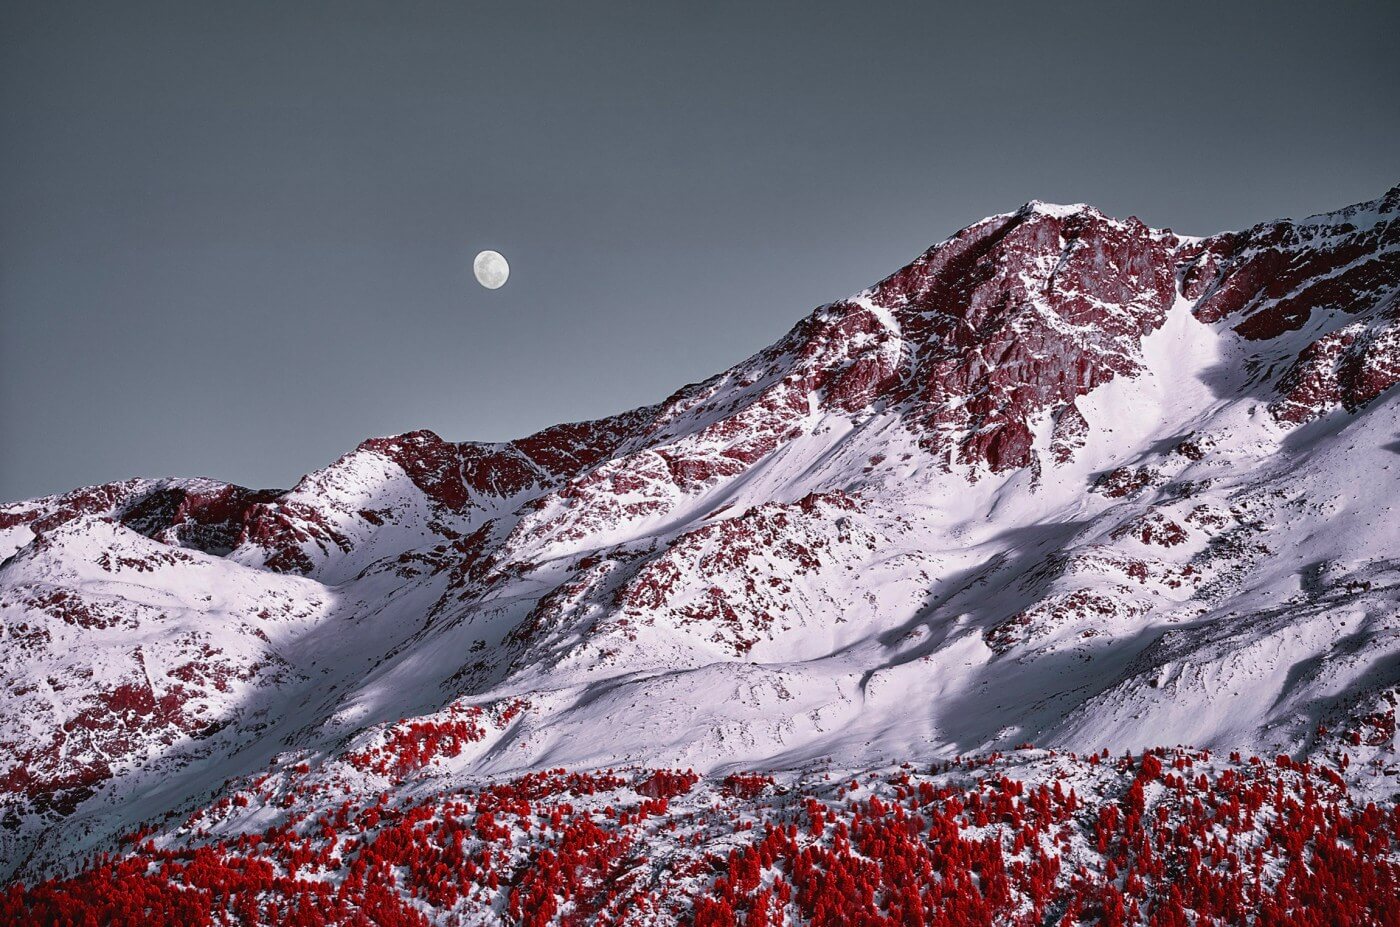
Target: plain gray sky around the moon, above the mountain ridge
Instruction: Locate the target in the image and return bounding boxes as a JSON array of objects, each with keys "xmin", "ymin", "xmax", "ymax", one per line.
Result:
[{"xmin": 0, "ymin": 0, "xmax": 1400, "ymax": 509}]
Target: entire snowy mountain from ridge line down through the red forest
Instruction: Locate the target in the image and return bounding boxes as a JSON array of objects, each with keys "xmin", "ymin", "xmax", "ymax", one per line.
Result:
[{"xmin": 0, "ymin": 186, "xmax": 1400, "ymax": 924}]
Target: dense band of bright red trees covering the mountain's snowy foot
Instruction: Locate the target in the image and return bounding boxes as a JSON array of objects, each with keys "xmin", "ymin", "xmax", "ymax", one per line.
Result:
[{"xmin": 0, "ymin": 751, "xmax": 1400, "ymax": 927}]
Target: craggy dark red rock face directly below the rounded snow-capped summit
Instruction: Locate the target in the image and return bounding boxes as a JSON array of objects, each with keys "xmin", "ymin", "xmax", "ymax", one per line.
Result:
[{"xmin": 871, "ymin": 206, "xmax": 1179, "ymax": 472}]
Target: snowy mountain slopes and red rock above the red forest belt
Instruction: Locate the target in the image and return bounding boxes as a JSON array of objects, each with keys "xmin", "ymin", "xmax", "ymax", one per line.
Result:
[{"xmin": 0, "ymin": 186, "xmax": 1400, "ymax": 923}]
